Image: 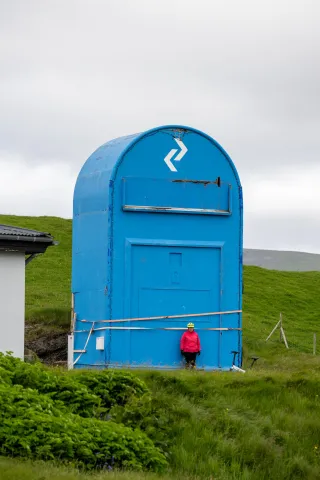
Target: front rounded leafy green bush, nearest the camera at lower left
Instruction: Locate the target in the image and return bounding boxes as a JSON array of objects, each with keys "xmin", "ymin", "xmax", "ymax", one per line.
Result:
[{"xmin": 0, "ymin": 384, "xmax": 166, "ymax": 471}]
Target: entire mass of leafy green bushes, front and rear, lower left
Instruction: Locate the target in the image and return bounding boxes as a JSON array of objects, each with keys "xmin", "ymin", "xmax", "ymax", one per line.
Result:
[{"xmin": 0, "ymin": 354, "xmax": 167, "ymax": 470}]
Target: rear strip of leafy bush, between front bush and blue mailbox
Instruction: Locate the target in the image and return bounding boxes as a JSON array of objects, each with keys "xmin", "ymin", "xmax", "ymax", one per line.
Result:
[{"xmin": 0, "ymin": 354, "xmax": 178, "ymax": 455}]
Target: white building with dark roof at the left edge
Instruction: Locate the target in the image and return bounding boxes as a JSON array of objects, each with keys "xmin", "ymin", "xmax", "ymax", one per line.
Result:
[{"xmin": 0, "ymin": 224, "xmax": 56, "ymax": 358}]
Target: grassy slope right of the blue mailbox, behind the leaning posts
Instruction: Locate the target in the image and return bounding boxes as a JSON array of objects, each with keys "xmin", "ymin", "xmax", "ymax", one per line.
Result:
[{"xmin": 243, "ymin": 267, "xmax": 320, "ymax": 353}]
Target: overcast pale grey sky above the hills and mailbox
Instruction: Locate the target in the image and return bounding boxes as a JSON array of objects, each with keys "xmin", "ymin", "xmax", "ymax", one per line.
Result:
[{"xmin": 0, "ymin": 0, "xmax": 320, "ymax": 252}]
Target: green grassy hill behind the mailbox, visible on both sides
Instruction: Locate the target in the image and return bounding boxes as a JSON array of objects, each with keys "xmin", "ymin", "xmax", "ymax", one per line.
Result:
[{"xmin": 0, "ymin": 215, "xmax": 320, "ymax": 364}]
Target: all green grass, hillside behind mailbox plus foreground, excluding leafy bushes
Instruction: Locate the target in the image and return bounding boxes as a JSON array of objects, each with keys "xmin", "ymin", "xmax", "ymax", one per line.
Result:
[{"xmin": 0, "ymin": 216, "xmax": 320, "ymax": 480}]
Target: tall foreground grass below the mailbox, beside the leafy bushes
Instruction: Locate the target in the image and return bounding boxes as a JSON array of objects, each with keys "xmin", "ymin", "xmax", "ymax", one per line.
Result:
[{"xmin": 0, "ymin": 372, "xmax": 320, "ymax": 480}]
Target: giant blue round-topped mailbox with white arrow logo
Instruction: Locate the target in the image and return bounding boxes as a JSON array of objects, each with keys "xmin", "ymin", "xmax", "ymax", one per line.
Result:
[{"xmin": 72, "ymin": 126, "xmax": 243, "ymax": 369}]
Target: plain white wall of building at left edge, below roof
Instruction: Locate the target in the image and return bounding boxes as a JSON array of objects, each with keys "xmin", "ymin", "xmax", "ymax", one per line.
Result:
[{"xmin": 0, "ymin": 252, "xmax": 25, "ymax": 358}]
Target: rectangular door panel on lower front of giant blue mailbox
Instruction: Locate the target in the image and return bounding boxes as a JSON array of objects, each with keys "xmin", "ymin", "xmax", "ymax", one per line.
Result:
[{"xmin": 126, "ymin": 245, "xmax": 221, "ymax": 367}]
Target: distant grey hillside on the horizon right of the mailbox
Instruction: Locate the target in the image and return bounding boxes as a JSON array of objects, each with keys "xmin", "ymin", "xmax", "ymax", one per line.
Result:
[{"xmin": 243, "ymin": 248, "xmax": 320, "ymax": 272}]
